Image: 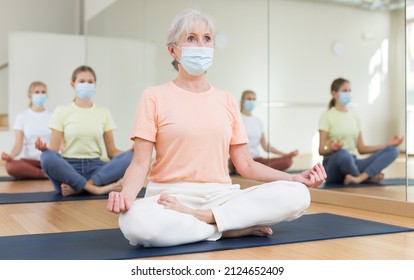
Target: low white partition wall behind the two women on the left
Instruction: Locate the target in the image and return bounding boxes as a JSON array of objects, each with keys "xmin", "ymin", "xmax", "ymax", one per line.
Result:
[{"xmin": 0, "ymin": 32, "xmax": 155, "ymax": 154}]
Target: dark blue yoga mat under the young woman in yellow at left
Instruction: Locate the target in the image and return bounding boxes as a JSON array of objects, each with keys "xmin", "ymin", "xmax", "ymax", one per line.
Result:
[{"xmin": 0, "ymin": 188, "xmax": 145, "ymax": 204}]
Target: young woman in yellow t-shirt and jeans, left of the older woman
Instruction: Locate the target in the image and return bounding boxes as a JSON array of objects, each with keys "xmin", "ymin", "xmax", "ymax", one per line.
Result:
[{"xmin": 36, "ymin": 66, "xmax": 132, "ymax": 196}]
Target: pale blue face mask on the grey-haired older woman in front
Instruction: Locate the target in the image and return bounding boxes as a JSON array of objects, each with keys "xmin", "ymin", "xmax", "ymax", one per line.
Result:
[{"xmin": 175, "ymin": 45, "xmax": 214, "ymax": 76}]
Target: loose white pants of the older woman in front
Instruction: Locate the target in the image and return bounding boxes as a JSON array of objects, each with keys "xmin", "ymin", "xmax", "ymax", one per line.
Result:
[{"xmin": 119, "ymin": 181, "xmax": 310, "ymax": 247}]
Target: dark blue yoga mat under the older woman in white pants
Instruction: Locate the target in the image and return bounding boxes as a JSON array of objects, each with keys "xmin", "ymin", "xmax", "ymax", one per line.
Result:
[{"xmin": 0, "ymin": 213, "xmax": 414, "ymax": 260}]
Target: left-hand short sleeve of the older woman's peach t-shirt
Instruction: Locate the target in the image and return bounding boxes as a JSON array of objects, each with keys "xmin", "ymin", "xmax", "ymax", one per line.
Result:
[{"xmin": 131, "ymin": 89, "xmax": 157, "ymax": 142}]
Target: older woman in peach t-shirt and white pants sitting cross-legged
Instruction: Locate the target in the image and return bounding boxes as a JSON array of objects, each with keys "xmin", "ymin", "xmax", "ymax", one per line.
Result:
[{"xmin": 107, "ymin": 10, "xmax": 326, "ymax": 246}]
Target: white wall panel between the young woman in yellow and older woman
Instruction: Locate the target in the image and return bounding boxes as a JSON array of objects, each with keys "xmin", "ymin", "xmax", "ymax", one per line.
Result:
[{"xmin": 86, "ymin": 36, "xmax": 157, "ymax": 150}]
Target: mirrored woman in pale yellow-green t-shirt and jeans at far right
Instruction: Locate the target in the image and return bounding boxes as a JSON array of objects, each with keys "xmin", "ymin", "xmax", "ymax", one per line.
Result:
[{"xmin": 319, "ymin": 78, "xmax": 403, "ymax": 185}]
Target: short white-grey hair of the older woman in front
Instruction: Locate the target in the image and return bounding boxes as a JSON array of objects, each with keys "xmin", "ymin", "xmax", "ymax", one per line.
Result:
[{"xmin": 167, "ymin": 9, "xmax": 215, "ymax": 71}]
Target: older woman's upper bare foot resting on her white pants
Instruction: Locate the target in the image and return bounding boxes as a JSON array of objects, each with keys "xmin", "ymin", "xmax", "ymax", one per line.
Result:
[{"xmin": 158, "ymin": 193, "xmax": 216, "ymax": 224}]
